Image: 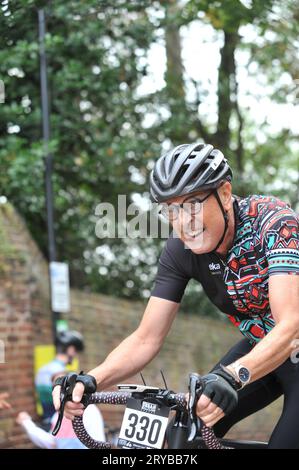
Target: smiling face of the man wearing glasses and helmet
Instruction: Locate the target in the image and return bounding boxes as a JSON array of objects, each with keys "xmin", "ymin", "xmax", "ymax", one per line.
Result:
[{"xmin": 162, "ymin": 183, "xmax": 231, "ymax": 254}]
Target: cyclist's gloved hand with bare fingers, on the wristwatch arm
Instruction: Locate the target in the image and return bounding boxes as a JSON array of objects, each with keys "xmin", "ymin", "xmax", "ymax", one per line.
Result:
[{"xmin": 196, "ymin": 369, "xmax": 238, "ymax": 427}]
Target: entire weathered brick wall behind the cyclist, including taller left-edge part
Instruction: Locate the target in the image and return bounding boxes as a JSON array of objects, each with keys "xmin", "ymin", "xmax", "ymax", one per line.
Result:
[{"xmin": 0, "ymin": 204, "xmax": 281, "ymax": 448}]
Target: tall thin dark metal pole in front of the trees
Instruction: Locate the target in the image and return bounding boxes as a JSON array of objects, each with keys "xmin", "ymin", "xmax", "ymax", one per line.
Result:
[{"xmin": 38, "ymin": 8, "xmax": 59, "ymax": 339}]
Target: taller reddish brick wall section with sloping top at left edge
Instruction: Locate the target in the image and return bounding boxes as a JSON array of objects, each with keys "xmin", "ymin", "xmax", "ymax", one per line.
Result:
[{"xmin": 0, "ymin": 204, "xmax": 51, "ymax": 448}]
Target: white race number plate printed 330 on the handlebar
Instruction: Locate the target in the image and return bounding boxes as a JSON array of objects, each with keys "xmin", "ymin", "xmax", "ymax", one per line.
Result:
[{"xmin": 118, "ymin": 398, "xmax": 169, "ymax": 449}]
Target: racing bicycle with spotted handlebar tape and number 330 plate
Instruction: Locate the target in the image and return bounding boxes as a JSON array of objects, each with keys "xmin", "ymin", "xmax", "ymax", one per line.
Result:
[{"xmin": 53, "ymin": 373, "xmax": 267, "ymax": 449}]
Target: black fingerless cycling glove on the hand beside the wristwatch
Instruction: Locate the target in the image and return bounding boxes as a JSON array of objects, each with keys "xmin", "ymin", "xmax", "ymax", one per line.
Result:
[{"xmin": 202, "ymin": 369, "xmax": 240, "ymax": 415}]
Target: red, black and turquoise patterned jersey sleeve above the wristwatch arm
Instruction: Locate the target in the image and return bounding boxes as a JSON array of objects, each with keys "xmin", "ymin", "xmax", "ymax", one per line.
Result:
[{"xmin": 259, "ymin": 198, "xmax": 299, "ymax": 276}]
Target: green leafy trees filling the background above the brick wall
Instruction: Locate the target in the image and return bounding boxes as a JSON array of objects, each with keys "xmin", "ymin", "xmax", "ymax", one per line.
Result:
[{"xmin": 0, "ymin": 0, "xmax": 299, "ymax": 316}]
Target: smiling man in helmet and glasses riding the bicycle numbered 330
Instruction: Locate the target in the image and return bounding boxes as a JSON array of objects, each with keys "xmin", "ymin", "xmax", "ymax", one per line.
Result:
[{"xmin": 53, "ymin": 143, "xmax": 299, "ymax": 448}]
